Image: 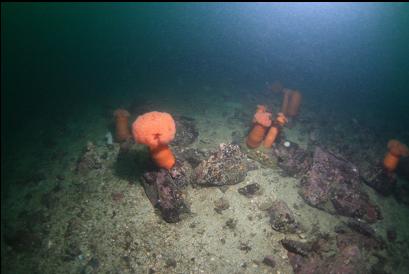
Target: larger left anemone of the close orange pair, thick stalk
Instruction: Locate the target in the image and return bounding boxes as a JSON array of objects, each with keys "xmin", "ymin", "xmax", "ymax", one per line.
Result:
[{"xmin": 246, "ymin": 108, "xmax": 271, "ymax": 148}]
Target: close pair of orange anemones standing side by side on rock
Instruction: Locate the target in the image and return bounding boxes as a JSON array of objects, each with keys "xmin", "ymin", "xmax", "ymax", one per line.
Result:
[{"xmin": 246, "ymin": 105, "xmax": 287, "ymax": 148}]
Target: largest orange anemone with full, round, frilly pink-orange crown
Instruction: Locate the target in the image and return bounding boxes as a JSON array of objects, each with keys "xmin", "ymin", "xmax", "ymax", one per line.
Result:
[{"xmin": 132, "ymin": 111, "xmax": 176, "ymax": 170}]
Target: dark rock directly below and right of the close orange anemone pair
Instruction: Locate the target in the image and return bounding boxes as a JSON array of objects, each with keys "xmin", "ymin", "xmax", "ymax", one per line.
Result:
[{"xmin": 273, "ymin": 140, "xmax": 312, "ymax": 176}]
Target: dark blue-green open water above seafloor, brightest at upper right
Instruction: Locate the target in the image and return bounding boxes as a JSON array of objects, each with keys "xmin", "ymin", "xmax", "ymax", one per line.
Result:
[{"xmin": 1, "ymin": 3, "xmax": 409, "ymax": 274}]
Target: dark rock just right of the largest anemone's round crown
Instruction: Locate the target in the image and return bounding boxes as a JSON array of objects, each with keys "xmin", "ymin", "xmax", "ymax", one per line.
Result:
[{"xmin": 172, "ymin": 116, "xmax": 199, "ymax": 147}]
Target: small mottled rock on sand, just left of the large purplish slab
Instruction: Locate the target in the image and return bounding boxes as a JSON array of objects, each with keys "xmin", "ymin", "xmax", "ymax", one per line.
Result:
[{"xmin": 268, "ymin": 200, "xmax": 299, "ymax": 233}]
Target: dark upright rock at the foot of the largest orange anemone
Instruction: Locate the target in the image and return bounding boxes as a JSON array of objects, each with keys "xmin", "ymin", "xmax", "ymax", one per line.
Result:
[{"xmin": 143, "ymin": 166, "xmax": 190, "ymax": 223}]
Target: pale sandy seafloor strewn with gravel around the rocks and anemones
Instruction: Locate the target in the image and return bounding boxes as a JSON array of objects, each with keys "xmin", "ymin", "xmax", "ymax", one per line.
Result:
[{"xmin": 1, "ymin": 85, "xmax": 409, "ymax": 274}]
